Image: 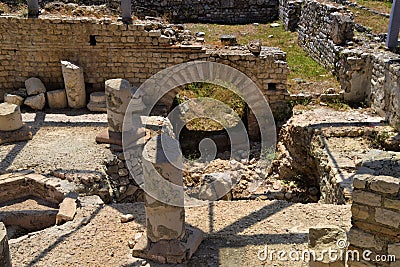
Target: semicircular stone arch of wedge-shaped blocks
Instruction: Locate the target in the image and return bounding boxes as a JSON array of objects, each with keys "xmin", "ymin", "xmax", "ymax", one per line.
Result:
[{"xmin": 138, "ymin": 61, "xmax": 276, "ymax": 147}]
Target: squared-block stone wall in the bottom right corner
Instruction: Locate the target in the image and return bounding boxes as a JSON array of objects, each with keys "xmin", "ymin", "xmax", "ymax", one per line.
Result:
[{"xmin": 348, "ymin": 150, "xmax": 400, "ymax": 266}]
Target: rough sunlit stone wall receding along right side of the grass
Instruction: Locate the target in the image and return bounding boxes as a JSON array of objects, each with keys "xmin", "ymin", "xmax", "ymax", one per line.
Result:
[{"xmin": 298, "ymin": 0, "xmax": 354, "ymax": 71}]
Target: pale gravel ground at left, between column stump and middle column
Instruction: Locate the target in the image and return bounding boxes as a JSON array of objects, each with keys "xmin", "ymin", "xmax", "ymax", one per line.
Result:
[{"xmin": 0, "ymin": 110, "xmax": 110, "ymax": 174}]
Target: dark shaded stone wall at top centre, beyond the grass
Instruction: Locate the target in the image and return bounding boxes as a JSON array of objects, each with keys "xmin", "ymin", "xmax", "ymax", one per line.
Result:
[{"xmin": 134, "ymin": 0, "xmax": 278, "ymax": 24}]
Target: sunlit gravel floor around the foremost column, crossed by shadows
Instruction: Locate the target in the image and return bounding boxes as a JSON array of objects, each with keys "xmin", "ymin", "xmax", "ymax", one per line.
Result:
[{"xmin": 10, "ymin": 200, "xmax": 351, "ymax": 267}]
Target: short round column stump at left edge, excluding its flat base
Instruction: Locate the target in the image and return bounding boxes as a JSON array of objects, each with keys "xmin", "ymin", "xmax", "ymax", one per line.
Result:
[{"xmin": 0, "ymin": 103, "xmax": 23, "ymax": 131}]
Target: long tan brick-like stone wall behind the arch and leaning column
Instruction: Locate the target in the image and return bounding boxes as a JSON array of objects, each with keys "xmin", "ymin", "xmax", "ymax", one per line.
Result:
[{"xmin": 0, "ymin": 16, "xmax": 289, "ymax": 118}]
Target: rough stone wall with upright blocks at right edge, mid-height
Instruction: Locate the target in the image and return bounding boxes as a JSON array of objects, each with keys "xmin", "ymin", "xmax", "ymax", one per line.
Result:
[{"xmin": 337, "ymin": 48, "xmax": 400, "ymax": 130}]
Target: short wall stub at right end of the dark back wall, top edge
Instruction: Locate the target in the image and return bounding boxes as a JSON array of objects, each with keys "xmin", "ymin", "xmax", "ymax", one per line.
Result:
[{"xmin": 279, "ymin": 0, "xmax": 304, "ymax": 31}]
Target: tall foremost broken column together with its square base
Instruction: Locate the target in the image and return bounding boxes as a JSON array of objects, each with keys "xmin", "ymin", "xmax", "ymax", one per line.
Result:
[{"xmin": 133, "ymin": 134, "xmax": 203, "ymax": 264}]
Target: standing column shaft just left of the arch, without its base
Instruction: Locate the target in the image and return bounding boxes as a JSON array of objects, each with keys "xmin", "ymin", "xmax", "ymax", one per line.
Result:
[{"xmin": 105, "ymin": 79, "xmax": 132, "ymax": 133}]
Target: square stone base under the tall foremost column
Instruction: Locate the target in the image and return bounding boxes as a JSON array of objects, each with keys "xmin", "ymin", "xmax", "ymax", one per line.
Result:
[{"xmin": 132, "ymin": 226, "xmax": 204, "ymax": 264}]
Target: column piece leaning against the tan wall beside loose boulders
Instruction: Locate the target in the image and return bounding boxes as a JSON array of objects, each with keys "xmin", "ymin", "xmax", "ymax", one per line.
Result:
[{"xmin": 61, "ymin": 61, "xmax": 86, "ymax": 108}]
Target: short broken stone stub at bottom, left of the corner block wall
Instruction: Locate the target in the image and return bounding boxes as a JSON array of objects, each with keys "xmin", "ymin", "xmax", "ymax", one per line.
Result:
[{"xmin": 308, "ymin": 226, "xmax": 348, "ymax": 267}]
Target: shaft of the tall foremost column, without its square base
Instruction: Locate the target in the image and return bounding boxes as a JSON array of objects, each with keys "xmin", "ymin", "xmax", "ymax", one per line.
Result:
[{"xmin": 143, "ymin": 134, "xmax": 185, "ymax": 243}]
